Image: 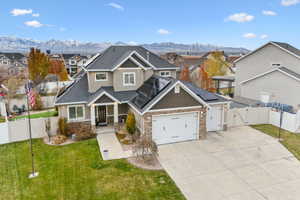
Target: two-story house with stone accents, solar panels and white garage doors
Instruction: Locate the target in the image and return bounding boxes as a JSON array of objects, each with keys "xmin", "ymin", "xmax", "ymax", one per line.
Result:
[{"xmin": 55, "ymin": 46, "xmax": 228, "ymax": 144}]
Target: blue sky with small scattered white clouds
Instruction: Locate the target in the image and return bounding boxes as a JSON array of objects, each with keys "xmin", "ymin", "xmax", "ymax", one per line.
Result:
[{"xmin": 0, "ymin": 0, "xmax": 300, "ymax": 49}]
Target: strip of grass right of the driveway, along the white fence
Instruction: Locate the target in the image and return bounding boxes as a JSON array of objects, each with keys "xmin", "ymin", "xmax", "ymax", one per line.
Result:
[{"xmin": 251, "ymin": 124, "xmax": 300, "ymax": 160}]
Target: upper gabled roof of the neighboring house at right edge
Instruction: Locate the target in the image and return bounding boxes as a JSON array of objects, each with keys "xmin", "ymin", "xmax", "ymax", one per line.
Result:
[{"xmin": 234, "ymin": 41, "xmax": 300, "ymax": 63}]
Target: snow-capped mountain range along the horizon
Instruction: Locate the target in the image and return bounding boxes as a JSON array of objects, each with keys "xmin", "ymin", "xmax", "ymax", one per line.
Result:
[{"xmin": 0, "ymin": 36, "xmax": 249, "ymax": 54}]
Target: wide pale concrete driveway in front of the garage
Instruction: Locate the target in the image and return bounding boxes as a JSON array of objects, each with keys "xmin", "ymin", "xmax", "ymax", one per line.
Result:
[{"xmin": 159, "ymin": 126, "xmax": 300, "ymax": 200}]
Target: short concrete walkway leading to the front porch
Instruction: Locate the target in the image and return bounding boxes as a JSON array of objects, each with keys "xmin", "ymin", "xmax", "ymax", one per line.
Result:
[{"xmin": 97, "ymin": 132, "xmax": 132, "ymax": 160}]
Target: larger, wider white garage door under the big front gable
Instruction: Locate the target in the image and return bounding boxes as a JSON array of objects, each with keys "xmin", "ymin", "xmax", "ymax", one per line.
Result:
[{"xmin": 152, "ymin": 112, "xmax": 199, "ymax": 144}]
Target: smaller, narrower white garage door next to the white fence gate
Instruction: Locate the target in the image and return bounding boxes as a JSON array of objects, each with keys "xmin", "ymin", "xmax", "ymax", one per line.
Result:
[{"xmin": 206, "ymin": 107, "xmax": 223, "ymax": 131}]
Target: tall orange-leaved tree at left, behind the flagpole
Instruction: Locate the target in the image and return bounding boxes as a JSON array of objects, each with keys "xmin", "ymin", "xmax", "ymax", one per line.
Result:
[{"xmin": 28, "ymin": 48, "xmax": 50, "ymax": 87}]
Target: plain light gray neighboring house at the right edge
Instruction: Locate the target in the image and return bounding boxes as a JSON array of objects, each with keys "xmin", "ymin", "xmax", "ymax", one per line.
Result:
[{"xmin": 235, "ymin": 42, "xmax": 300, "ymax": 109}]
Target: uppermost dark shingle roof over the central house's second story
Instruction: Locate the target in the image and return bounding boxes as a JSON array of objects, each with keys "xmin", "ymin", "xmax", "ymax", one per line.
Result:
[{"xmin": 87, "ymin": 46, "xmax": 177, "ymax": 70}]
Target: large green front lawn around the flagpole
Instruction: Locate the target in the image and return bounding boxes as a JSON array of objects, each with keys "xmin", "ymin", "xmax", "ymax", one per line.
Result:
[{"xmin": 0, "ymin": 139, "xmax": 184, "ymax": 200}]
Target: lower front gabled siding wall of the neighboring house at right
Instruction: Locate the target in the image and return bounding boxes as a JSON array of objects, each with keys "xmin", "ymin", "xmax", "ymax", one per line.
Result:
[{"xmin": 240, "ymin": 71, "xmax": 300, "ymax": 108}]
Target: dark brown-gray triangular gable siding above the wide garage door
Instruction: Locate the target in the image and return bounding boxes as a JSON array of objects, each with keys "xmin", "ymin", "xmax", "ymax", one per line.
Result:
[{"xmin": 151, "ymin": 88, "xmax": 201, "ymax": 110}]
